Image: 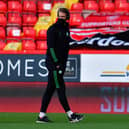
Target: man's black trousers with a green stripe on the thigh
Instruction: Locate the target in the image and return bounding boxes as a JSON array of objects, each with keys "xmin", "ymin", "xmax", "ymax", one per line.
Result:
[{"xmin": 40, "ymin": 70, "xmax": 70, "ymax": 112}]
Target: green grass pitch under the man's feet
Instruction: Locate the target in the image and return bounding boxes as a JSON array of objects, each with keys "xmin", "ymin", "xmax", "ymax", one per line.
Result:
[{"xmin": 0, "ymin": 113, "xmax": 129, "ymax": 129}]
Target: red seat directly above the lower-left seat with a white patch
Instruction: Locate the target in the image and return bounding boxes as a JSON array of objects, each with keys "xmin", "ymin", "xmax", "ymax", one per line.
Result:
[{"xmin": 7, "ymin": 13, "xmax": 22, "ymax": 26}]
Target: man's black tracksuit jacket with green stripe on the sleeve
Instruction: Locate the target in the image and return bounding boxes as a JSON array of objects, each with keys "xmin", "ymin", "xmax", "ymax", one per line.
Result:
[{"xmin": 46, "ymin": 19, "xmax": 72, "ymax": 70}]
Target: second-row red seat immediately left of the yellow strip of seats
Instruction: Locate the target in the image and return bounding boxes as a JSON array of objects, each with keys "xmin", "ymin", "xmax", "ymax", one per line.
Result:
[{"xmin": 22, "ymin": 15, "xmax": 37, "ymax": 26}]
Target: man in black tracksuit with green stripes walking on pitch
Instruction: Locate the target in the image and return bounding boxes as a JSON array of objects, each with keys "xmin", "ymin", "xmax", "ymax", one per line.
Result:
[{"xmin": 36, "ymin": 8, "xmax": 83, "ymax": 123}]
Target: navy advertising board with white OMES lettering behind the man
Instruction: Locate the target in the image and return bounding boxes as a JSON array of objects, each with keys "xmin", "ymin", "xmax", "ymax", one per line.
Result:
[{"xmin": 0, "ymin": 54, "xmax": 80, "ymax": 82}]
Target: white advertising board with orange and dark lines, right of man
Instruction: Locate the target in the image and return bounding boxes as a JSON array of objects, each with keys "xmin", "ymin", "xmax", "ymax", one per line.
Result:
[{"xmin": 80, "ymin": 54, "xmax": 129, "ymax": 82}]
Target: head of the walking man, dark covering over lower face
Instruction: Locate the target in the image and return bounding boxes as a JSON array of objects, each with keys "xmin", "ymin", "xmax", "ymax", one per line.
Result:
[{"xmin": 57, "ymin": 8, "xmax": 70, "ymax": 21}]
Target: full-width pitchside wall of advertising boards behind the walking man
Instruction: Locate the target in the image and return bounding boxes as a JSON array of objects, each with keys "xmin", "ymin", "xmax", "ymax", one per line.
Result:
[{"xmin": 0, "ymin": 51, "xmax": 129, "ymax": 114}]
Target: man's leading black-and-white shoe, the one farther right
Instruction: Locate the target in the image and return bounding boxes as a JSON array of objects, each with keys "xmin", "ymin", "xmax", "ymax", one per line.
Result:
[{"xmin": 68, "ymin": 113, "xmax": 84, "ymax": 123}]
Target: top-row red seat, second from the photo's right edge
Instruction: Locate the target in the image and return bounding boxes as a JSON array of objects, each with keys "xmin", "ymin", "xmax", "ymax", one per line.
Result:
[{"xmin": 99, "ymin": 1, "xmax": 115, "ymax": 12}]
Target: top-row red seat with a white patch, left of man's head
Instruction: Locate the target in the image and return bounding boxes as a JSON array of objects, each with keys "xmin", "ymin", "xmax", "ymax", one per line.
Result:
[{"xmin": 37, "ymin": 1, "xmax": 52, "ymax": 13}]
